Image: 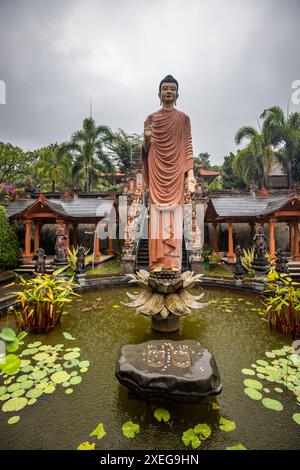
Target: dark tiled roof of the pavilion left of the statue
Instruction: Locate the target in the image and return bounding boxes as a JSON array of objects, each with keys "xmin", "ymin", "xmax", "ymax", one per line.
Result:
[{"xmin": 7, "ymin": 198, "xmax": 114, "ymax": 219}]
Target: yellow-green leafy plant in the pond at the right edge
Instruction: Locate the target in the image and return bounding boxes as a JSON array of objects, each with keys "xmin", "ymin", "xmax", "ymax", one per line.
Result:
[{"xmin": 265, "ymin": 270, "xmax": 300, "ymax": 338}]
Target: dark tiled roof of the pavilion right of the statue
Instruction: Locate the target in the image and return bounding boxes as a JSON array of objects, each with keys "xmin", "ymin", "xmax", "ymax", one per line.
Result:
[{"xmin": 211, "ymin": 195, "xmax": 291, "ymax": 217}]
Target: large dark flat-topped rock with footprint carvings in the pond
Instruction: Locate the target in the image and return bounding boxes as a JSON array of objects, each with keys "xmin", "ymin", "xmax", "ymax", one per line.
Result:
[{"xmin": 116, "ymin": 340, "xmax": 222, "ymax": 403}]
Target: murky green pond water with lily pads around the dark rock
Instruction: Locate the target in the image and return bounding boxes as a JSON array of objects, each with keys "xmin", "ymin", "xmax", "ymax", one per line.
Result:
[{"xmin": 0, "ymin": 288, "xmax": 300, "ymax": 450}]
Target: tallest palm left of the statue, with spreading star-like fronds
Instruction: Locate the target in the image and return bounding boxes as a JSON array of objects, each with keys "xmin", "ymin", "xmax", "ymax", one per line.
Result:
[{"xmin": 66, "ymin": 117, "xmax": 114, "ymax": 191}]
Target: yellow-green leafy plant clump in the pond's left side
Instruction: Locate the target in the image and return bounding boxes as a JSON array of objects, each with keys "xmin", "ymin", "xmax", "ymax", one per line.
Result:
[{"xmin": 14, "ymin": 274, "xmax": 79, "ymax": 333}]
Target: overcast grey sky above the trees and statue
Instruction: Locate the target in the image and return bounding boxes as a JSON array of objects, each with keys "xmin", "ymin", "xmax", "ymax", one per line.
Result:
[{"xmin": 0, "ymin": 0, "xmax": 300, "ymax": 163}]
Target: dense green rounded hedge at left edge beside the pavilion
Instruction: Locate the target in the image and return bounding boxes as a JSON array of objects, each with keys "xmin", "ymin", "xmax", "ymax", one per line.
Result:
[{"xmin": 0, "ymin": 205, "xmax": 19, "ymax": 270}]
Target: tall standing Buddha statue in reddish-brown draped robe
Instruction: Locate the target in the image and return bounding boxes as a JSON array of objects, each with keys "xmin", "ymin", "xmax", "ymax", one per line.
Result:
[{"xmin": 142, "ymin": 75, "xmax": 196, "ymax": 271}]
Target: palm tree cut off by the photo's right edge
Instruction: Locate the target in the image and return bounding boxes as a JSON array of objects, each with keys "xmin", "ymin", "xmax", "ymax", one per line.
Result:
[{"xmin": 260, "ymin": 106, "xmax": 300, "ymax": 188}]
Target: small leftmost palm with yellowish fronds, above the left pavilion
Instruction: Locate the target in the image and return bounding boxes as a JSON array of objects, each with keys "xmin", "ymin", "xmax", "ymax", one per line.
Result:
[{"xmin": 35, "ymin": 143, "xmax": 72, "ymax": 192}]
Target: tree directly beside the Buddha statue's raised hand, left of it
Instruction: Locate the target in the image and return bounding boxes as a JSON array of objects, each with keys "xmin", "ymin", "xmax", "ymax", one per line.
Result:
[{"xmin": 108, "ymin": 129, "xmax": 143, "ymax": 173}]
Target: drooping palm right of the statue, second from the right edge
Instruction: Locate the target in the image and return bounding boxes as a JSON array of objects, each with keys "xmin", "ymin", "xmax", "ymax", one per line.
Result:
[{"xmin": 233, "ymin": 124, "xmax": 275, "ymax": 189}]
